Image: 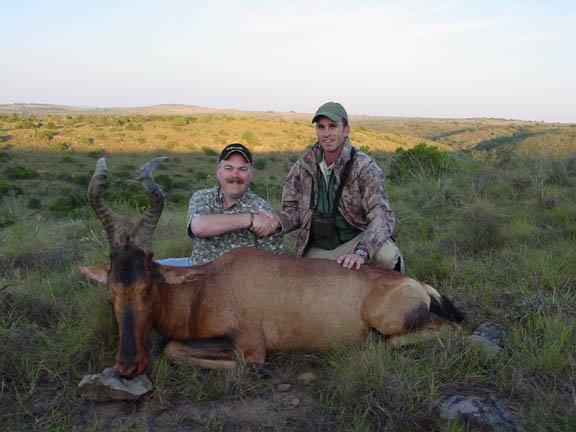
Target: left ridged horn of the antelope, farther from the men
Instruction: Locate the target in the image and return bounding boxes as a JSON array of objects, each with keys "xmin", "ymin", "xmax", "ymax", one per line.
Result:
[{"xmin": 88, "ymin": 158, "xmax": 121, "ymax": 246}]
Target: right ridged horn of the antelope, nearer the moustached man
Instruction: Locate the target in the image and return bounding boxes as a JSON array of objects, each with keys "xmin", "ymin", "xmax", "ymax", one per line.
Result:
[{"xmin": 132, "ymin": 157, "xmax": 168, "ymax": 251}]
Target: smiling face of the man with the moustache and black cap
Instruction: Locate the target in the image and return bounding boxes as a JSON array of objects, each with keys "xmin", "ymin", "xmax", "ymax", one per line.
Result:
[{"xmin": 216, "ymin": 153, "xmax": 252, "ymax": 205}]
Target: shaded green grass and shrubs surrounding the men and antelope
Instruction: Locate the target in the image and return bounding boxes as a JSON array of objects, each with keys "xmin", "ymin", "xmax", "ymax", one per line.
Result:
[{"xmin": 0, "ymin": 113, "xmax": 576, "ymax": 431}]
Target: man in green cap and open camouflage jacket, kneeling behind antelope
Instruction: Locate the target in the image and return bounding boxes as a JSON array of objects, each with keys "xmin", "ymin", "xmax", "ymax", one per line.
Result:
[{"xmin": 260, "ymin": 102, "xmax": 404, "ymax": 271}]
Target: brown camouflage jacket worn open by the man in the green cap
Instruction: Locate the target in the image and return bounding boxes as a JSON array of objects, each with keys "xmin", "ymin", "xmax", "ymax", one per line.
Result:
[{"xmin": 279, "ymin": 139, "xmax": 395, "ymax": 257}]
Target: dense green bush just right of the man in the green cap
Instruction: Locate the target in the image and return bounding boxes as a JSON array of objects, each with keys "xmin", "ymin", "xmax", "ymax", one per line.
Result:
[{"xmin": 388, "ymin": 143, "xmax": 459, "ymax": 180}]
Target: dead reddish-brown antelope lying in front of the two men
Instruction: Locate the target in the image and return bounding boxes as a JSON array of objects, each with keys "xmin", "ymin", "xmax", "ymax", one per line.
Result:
[{"xmin": 79, "ymin": 158, "xmax": 462, "ymax": 377}]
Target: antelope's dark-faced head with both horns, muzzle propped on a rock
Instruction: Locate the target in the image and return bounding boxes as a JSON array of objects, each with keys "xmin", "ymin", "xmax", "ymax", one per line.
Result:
[{"xmin": 79, "ymin": 157, "xmax": 166, "ymax": 377}]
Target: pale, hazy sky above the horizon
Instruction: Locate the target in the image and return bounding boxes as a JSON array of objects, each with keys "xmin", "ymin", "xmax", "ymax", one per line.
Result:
[{"xmin": 0, "ymin": 0, "xmax": 576, "ymax": 123}]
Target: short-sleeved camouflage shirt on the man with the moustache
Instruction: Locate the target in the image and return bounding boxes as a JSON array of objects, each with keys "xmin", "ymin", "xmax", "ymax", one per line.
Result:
[{"xmin": 186, "ymin": 187, "xmax": 284, "ymax": 265}]
